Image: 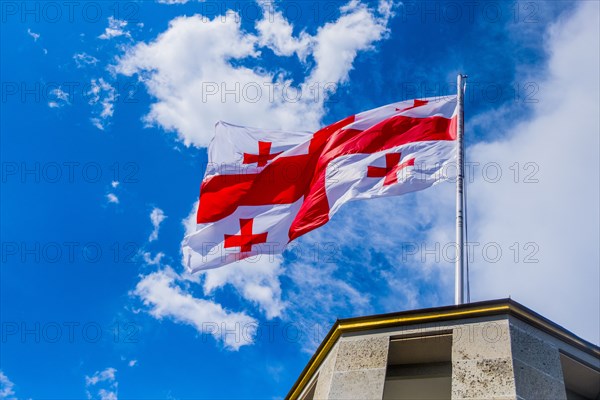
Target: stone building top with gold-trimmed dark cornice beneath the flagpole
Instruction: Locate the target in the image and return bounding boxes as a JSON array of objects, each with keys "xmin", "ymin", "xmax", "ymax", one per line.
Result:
[{"xmin": 287, "ymin": 299, "xmax": 600, "ymax": 400}]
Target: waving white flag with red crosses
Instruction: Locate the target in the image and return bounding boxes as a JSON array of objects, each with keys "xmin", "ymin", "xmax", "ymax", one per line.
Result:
[{"xmin": 183, "ymin": 96, "xmax": 457, "ymax": 272}]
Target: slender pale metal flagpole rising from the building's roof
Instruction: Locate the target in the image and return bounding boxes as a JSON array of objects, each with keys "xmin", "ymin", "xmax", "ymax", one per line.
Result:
[{"xmin": 454, "ymin": 74, "xmax": 467, "ymax": 305}]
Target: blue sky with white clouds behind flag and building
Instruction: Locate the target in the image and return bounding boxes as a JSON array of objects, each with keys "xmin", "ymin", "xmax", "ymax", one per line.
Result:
[{"xmin": 0, "ymin": 0, "xmax": 600, "ymax": 400}]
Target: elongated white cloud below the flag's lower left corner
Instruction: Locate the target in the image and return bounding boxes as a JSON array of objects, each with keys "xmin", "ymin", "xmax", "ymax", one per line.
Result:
[{"xmin": 133, "ymin": 267, "xmax": 257, "ymax": 351}]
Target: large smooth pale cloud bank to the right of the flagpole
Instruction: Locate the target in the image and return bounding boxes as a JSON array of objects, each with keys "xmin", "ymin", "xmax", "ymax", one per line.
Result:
[{"xmin": 460, "ymin": 2, "xmax": 600, "ymax": 343}]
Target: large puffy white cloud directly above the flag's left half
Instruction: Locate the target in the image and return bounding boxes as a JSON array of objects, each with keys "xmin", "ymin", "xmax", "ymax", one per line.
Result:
[{"xmin": 115, "ymin": 2, "xmax": 389, "ymax": 147}]
